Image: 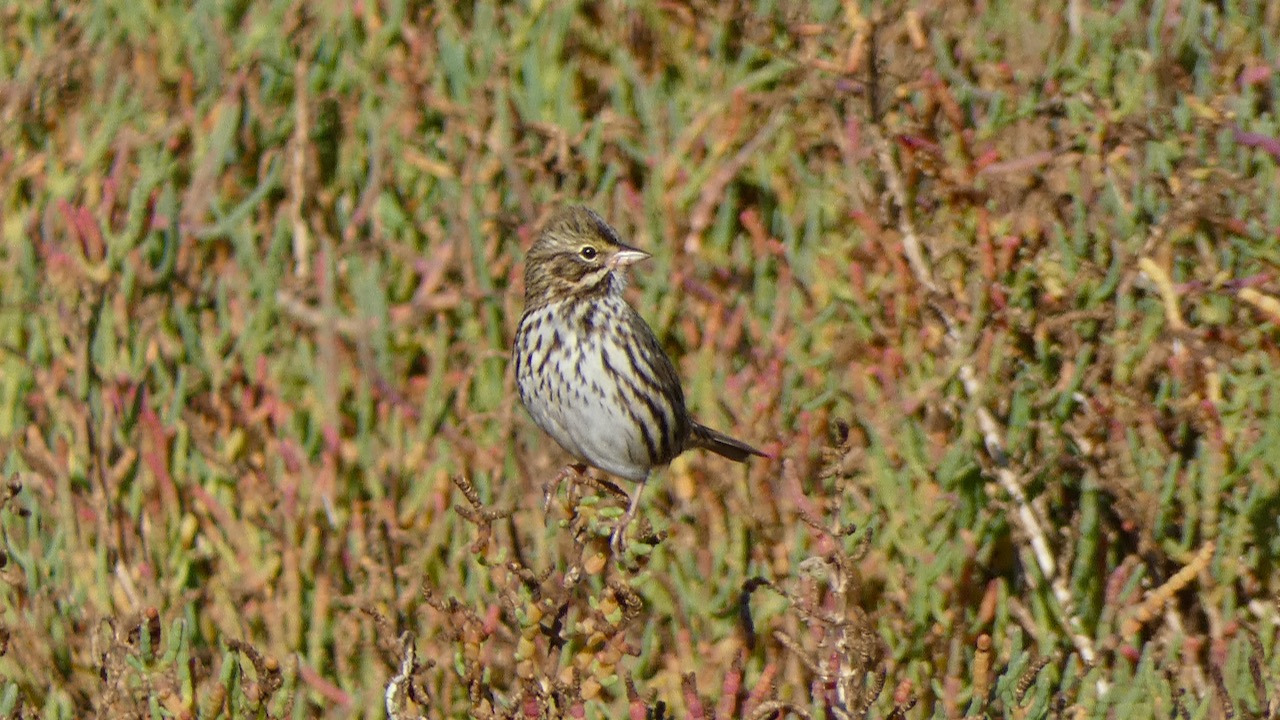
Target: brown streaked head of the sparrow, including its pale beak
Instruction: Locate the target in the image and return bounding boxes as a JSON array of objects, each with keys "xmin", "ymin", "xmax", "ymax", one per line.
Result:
[{"xmin": 525, "ymin": 205, "xmax": 649, "ymax": 311}]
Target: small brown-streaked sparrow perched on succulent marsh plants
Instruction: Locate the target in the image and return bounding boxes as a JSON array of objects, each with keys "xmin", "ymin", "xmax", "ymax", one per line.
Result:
[{"xmin": 512, "ymin": 205, "xmax": 767, "ymax": 548}]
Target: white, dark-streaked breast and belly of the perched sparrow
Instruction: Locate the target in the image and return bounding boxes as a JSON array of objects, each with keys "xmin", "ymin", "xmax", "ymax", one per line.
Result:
[{"xmin": 516, "ymin": 319, "xmax": 653, "ymax": 482}]
